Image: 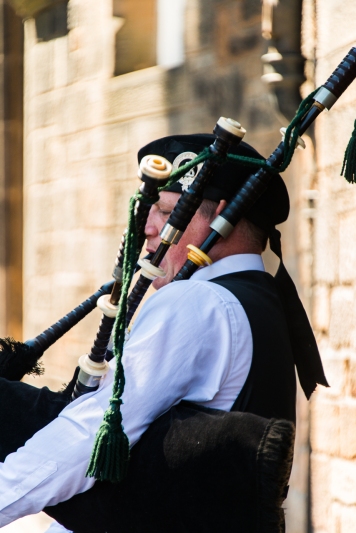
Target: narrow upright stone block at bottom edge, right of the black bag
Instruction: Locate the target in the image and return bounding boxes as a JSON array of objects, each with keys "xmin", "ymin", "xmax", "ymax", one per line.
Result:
[{"xmin": 310, "ymin": 453, "xmax": 331, "ymax": 532}]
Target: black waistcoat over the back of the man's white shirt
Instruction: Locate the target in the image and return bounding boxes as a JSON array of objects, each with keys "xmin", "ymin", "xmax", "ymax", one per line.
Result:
[{"xmin": 211, "ymin": 270, "xmax": 296, "ymax": 422}]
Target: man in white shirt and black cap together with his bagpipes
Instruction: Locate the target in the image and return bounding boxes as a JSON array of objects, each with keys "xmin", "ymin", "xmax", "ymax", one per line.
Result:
[{"xmin": 0, "ymin": 41, "xmax": 356, "ymax": 533}]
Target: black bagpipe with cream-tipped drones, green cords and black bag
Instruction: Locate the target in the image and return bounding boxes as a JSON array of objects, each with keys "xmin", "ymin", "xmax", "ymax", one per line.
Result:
[{"xmin": 0, "ymin": 48, "xmax": 356, "ymax": 533}]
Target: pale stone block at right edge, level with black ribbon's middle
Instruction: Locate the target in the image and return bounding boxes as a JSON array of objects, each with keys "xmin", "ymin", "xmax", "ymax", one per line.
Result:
[{"xmin": 329, "ymin": 287, "xmax": 354, "ymax": 348}]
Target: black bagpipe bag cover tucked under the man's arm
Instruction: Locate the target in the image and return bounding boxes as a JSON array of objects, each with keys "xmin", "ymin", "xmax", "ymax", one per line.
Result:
[{"xmin": 45, "ymin": 402, "xmax": 294, "ymax": 533}]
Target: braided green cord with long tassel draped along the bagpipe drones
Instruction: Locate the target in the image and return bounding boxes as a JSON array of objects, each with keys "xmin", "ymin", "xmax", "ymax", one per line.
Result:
[{"xmin": 86, "ymin": 91, "xmax": 322, "ymax": 482}]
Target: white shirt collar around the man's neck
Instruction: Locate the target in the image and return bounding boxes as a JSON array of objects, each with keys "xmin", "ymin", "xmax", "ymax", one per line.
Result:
[{"xmin": 191, "ymin": 254, "xmax": 265, "ymax": 281}]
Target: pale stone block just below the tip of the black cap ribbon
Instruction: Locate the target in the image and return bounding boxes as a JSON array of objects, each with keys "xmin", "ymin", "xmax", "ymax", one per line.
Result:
[{"xmin": 310, "ymin": 396, "xmax": 340, "ymax": 455}]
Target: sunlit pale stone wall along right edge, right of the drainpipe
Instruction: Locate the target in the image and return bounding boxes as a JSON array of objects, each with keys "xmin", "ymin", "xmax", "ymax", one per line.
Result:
[{"xmin": 303, "ymin": 0, "xmax": 356, "ymax": 533}]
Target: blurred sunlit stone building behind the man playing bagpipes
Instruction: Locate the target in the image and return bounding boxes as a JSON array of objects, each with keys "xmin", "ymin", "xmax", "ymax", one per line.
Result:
[{"xmin": 0, "ymin": 0, "xmax": 356, "ymax": 533}]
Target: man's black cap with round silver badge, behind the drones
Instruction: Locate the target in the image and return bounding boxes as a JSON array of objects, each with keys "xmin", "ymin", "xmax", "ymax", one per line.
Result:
[{"xmin": 138, "ymin": 133, "xmax": 289, "ymax": 231}]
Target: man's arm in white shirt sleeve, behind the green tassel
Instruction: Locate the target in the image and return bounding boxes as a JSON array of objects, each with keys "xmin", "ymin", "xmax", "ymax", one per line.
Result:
[{"xmin": 0, "ymin": 282, "xmax": 250, "ymax": 526}]
